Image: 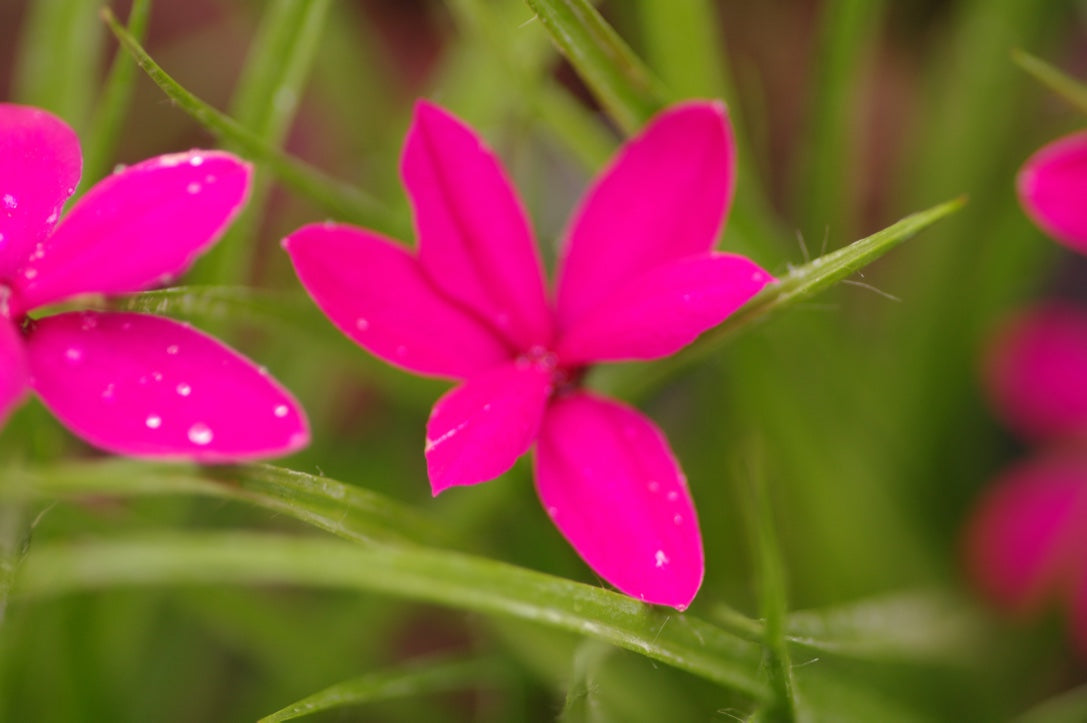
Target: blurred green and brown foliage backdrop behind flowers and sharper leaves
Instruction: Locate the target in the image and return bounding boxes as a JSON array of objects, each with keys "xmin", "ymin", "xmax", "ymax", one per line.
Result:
[{"xmin": 0, "ymin": 0, "xmax": 1087, "ymax": 722}]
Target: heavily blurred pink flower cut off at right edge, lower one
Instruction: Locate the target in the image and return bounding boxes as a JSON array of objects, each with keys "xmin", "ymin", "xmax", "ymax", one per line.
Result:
[{"xmin": 966, "ymin": 302, "xmax": 1087, "ymax": 651}]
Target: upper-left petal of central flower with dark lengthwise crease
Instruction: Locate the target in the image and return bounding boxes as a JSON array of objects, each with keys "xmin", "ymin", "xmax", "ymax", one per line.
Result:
[{"xmin": 401, "ymin": 102, "xmax": 551, "ymax": 348}]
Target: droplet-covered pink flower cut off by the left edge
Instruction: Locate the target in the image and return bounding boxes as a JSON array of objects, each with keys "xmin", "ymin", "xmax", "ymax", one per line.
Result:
[{"xmin": 0, "ymin": 104, "xmax": 309, "ymax": 462}]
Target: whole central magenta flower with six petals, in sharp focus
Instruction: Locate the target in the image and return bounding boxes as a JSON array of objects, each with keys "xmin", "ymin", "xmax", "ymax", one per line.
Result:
[{"xmin": 284, "ymin": 102, "xmax": 773, "ymax": 609}]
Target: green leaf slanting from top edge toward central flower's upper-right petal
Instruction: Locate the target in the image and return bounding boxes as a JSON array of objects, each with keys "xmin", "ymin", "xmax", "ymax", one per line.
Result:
[{"xmin": 526, "ymin": 0, "xmax": 664, "ymax": 135}]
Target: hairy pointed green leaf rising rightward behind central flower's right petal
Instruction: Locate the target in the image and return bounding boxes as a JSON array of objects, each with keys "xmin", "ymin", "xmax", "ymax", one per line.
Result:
[{"xmin": 621, "ymin": 198, "xmax": 966, "ymax": 396}]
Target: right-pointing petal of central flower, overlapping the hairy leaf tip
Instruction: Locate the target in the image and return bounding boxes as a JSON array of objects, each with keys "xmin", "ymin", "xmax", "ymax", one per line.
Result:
[{"xmin": 558, "ymin": 253, "xmax": 774, "ymax": 364}]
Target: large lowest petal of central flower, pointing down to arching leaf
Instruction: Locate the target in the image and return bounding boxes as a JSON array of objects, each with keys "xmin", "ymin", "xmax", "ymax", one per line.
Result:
[{"xmin": 536, "ymin": 392, "xmax": 703, "ymax": 610}]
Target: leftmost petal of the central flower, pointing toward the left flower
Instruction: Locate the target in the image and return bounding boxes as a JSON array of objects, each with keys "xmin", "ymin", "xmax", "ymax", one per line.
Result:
[{"xmin": 283, "ymin": 224, "xmax": 512, "ymax": 378}]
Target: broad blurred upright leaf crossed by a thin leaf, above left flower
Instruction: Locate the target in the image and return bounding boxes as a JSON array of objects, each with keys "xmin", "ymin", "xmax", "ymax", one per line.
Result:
[{"xmin": 193, "ymin": 0, "xmax": 330, "ymax": 283}]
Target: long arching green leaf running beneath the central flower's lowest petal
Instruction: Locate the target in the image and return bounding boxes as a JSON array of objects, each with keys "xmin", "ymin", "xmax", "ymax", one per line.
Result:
[{"xmin": 15, "ymin": 533, "xmax": 766, "ymax": 699}]
